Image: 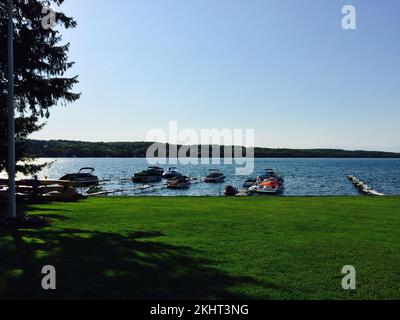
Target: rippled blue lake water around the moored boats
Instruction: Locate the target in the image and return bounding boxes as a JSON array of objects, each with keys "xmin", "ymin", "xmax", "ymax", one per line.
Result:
[{"xmin": 29, "ymin": 158, "xmax": 400, "ymax": 196}]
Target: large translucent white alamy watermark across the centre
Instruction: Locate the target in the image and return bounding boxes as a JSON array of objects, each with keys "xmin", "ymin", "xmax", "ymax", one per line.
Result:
[{"xmin": 146, "ymin": 121, "xmax": 254, "ymax": 175}]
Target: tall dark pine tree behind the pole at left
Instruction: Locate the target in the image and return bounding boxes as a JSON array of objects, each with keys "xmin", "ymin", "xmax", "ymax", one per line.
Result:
[{"xmin": 0, "ymin": 0, "xmax": 80, "ymax": 174}]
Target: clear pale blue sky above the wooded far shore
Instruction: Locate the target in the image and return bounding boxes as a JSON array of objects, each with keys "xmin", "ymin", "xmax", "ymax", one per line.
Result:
[{"xmin": 33, "ymin": 0, "xmax": 400, "ymax": 151}]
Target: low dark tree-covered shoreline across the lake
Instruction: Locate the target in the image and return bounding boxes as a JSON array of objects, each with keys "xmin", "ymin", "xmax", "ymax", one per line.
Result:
[{"xmin": 18, "ymin": 140, "xmax": 400, "ymax": 159}]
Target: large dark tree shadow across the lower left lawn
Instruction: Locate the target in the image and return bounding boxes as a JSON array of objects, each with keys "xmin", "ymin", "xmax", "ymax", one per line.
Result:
[{"xmin": 0, "ymin": 224, "xmax": 282, "ymax": 299}]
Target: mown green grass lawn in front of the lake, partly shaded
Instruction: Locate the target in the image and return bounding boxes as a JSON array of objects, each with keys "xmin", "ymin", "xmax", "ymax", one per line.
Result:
[{"xmin": 0, "ymin": 197, "xmax": 400, "ymax": 299}]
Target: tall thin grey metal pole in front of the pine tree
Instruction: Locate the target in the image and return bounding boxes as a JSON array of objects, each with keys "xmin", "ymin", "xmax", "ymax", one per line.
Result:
[{"xmin": 7, "ymin": 0, "xmax": 17, "ymax": 218}]
